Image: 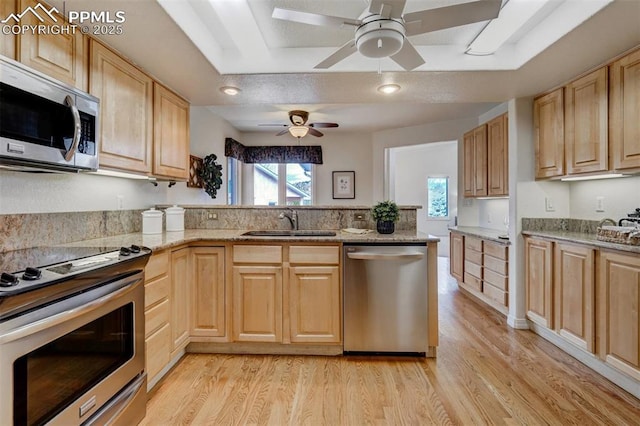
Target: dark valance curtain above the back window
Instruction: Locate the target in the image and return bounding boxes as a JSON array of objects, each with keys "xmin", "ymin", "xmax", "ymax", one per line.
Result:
[{"xmin": 224, "ymin": 138, "xmax": 322, "ymax": 164}]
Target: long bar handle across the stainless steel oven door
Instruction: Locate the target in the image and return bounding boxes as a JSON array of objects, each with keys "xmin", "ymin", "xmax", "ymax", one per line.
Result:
[{"xmin": 0, "ymin": 279, "xmax": 137, "ymax": 344}]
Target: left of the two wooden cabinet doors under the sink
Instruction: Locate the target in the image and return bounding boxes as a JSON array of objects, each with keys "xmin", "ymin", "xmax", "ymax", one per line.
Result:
[{"xmin": 233, "ymin": 266, "xmax": 282, "ymax": 343}]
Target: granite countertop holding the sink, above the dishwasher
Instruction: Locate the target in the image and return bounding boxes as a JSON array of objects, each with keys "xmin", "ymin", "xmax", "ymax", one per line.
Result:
[{"xmin": 61, "ymin": 229, "xmax": 440, "ymax": 250}]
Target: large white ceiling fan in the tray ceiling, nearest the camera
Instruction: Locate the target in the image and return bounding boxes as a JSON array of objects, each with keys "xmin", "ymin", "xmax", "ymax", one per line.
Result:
[{"xmin": 271, "ymin": 0, "xmax": 502, "ymax": 71}]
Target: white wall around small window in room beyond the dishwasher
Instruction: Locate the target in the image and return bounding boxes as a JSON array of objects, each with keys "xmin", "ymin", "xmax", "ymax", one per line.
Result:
[{"xmin": 389, "ymin": 141, "xmax": 458, "ymax": 257}]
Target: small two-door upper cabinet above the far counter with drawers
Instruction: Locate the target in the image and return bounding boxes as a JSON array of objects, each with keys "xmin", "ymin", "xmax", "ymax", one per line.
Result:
[{"xmin": 462, "ymin": 114, "xmax": 509, "ymax": 197}]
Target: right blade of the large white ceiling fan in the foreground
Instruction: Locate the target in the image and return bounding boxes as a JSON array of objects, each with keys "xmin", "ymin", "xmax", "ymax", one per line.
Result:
[{"xmin": 404, "ymin": 0, "xmax": 502, "ymax": 37}]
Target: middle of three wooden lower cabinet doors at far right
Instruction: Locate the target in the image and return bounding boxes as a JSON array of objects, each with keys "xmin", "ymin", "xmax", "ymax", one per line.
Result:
[{"xmin": 554, "ymin": 243, "xmax": 595, "ymax": 352}]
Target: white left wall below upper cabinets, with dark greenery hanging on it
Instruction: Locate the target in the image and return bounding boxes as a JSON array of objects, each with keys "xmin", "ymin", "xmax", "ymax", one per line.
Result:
[{"xmin": 0, "ymin": 107, "xmax": 239, "ymax": 214}]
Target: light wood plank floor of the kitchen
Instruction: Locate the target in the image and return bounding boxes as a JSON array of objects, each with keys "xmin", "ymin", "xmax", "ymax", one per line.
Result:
[{"xmin": 142, "ymin": 259, "xmax": 640, "ymax": 426}]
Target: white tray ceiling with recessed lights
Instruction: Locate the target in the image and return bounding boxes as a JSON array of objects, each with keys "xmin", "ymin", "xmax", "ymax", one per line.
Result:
[{"xmin": 49, "ymin": 0, "xmax": 640, "ymax": 133}]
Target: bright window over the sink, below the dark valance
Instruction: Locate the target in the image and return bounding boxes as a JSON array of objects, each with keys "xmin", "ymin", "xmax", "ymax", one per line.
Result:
[{"xmin": 253, "ymin": 163, "xmax": 313, "ymax": 206}]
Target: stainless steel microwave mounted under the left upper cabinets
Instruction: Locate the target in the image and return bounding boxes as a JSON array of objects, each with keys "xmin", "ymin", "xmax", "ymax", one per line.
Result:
[{"xmin": 0, "ymin": 56, "xmax": 100, "ymax": 172}]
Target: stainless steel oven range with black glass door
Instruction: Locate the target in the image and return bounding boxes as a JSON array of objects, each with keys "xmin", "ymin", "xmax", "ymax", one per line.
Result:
[{"xmin": 0, "ymin": 249, "xmax": 150, "ymax": 425}]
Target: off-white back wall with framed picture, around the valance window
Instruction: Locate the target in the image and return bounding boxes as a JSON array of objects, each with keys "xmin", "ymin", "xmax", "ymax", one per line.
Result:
[{"xmin": 236, "ymin": 129, "xmax": 373, "ymax": 206}]
